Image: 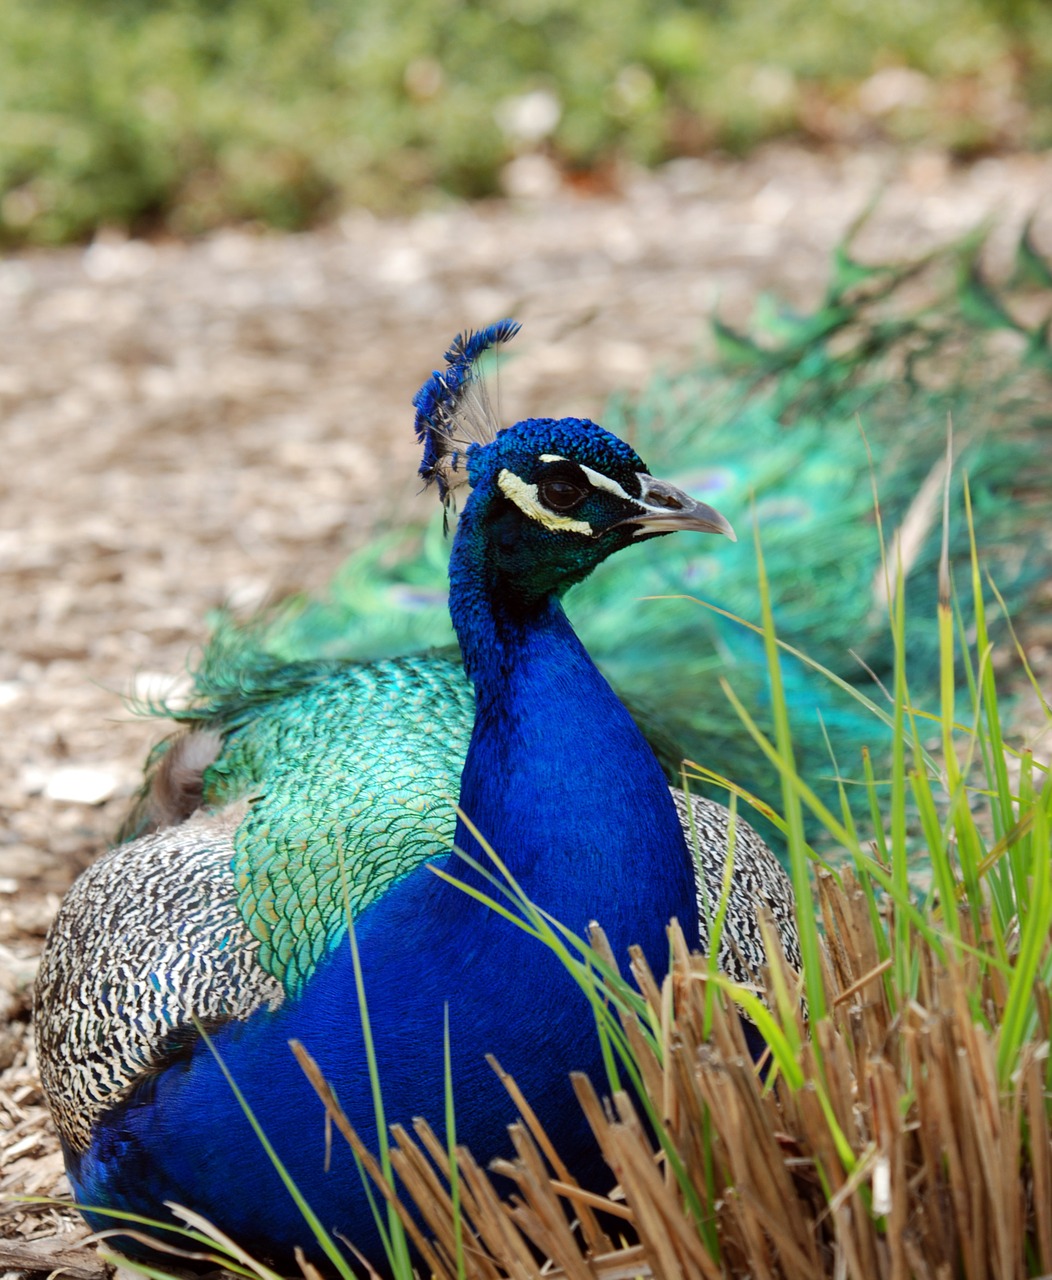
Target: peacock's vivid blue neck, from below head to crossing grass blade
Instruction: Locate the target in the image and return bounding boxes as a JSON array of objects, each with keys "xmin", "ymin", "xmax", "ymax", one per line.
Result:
[{"xmin": 449, "ymin": 514, "xmax": 696, "ymax": 961}]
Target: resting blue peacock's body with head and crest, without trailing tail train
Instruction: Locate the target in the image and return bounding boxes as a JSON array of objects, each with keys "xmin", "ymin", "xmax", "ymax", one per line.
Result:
[{"xmin": 36, "ymin": 321, "xmax": 799, "ymax": 1270}]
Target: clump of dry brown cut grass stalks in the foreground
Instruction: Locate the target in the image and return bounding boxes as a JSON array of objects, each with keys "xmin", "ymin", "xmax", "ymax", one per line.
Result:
[{"xmin": 299, "ymin": 874, "xmax": 1052, "ymax": 1280}]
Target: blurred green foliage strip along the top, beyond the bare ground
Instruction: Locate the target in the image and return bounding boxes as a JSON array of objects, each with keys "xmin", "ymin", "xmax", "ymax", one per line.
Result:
[{"xmin": 0, "ymin": 0, "xmax": 1052, "ymax": 243}]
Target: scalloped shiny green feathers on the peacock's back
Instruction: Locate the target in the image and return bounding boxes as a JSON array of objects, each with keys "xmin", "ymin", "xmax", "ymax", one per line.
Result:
[{"xmin": 205, "ymin": 657, "xmax": 474, "ymax": 997}]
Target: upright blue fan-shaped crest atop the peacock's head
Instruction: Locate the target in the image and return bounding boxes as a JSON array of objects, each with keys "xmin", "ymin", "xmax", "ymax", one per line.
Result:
[{"xmin": 413, "ymin": 320, "xmax": 521, "ymax": 502}]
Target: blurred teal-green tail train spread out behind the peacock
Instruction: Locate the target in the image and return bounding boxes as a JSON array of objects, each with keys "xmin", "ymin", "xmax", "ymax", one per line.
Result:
[{"xmin": 195, "ymin": 233, "xmax": 1052, "ymax": 819}]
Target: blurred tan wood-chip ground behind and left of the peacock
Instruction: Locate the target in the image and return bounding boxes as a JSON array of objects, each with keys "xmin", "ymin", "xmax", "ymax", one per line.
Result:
[{"xmin": 0, "ymin": 147, "xmax": 1052, "ymax": 1276}]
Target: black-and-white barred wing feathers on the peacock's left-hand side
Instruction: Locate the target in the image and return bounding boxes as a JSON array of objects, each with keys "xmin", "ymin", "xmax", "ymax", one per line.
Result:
[{"xmin": 36, "ymin": 805, "xmax": 284, "ymax": 1151}]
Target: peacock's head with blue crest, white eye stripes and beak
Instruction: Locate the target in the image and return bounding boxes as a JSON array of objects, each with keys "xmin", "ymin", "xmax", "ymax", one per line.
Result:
[{"xmin": 413, "ymin": 320, "xmax": 735, "ymax": 604}]
